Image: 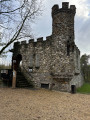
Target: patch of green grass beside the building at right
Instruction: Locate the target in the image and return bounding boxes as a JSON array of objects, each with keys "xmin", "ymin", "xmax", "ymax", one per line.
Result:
[{"xmin": 77, "ymin": 83, "xmax": 90, "ymax": 93}]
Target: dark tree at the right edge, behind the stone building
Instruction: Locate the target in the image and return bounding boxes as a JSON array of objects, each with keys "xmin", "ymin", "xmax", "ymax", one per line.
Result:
[{"xmin": 80, "ymin": 54, "xmax": 90, "ymax": 80}]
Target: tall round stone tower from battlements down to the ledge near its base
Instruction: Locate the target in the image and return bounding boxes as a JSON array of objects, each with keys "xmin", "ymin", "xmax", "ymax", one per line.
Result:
[{"xmin": 52, "ymin": 2, "xmax": 76, "ymax": 74}]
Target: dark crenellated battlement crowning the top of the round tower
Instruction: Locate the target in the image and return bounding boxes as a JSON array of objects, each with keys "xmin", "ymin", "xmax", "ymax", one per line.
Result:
[{"xmin": 52, "ymin": 2, "xmax": 76, "ymax": 16}]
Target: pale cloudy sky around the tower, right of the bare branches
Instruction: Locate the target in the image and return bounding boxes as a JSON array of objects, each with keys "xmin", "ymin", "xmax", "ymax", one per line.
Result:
[{"xmin": 33, "ymin": 0, "xmax": 90, "ymax": 55}]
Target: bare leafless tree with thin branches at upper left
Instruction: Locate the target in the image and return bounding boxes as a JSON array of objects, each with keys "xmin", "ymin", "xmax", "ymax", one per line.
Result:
[{"xmin": 0, "ymin": 0, "xmax": 41, "ymax": 55}]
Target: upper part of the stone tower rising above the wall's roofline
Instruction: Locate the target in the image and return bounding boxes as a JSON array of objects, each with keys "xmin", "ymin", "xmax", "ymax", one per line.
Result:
[{"xmin": 52, "ymin": 2, "xmax": 76, "ymax": 40}]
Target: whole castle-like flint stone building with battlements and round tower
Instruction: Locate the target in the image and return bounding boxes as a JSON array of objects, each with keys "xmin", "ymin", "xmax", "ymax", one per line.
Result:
[{"xmin": 13, "ymin": 2, "xmax": 83, "ymax": 91}]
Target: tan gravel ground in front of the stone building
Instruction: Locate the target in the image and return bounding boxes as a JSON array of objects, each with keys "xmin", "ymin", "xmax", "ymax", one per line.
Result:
[{"xmin": 0, "ymin": 88, "xmax": 90, "ymax": 120}]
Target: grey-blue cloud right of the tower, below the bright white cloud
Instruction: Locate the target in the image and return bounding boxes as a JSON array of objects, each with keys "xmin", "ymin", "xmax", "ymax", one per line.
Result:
[{"xmin": 75, "ymin": 18, "xmax": 90, "ymax": 54}]
